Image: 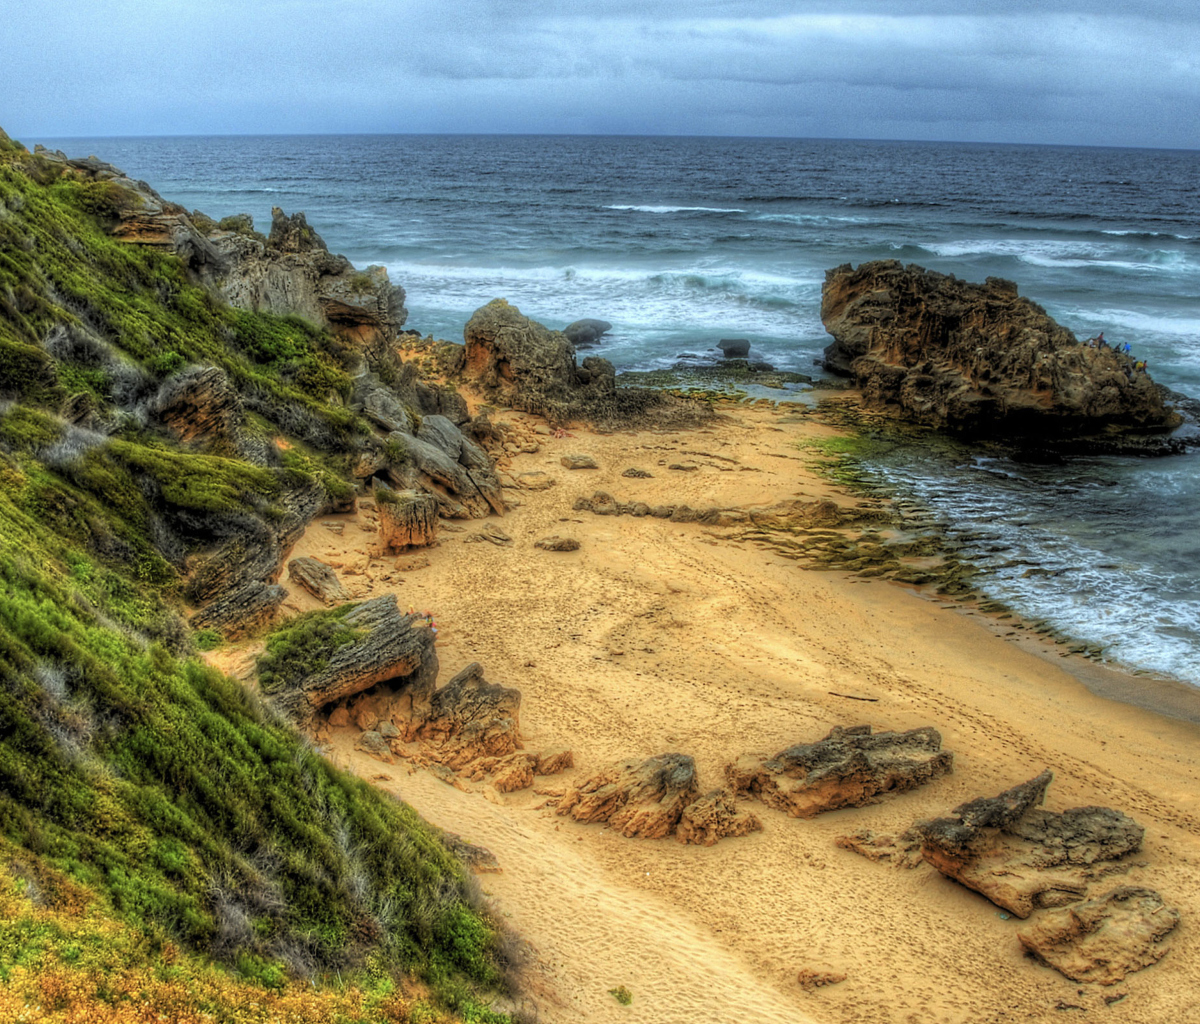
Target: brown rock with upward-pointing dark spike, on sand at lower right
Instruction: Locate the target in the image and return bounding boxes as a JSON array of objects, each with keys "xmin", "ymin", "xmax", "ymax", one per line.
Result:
[{"xmin": 914, "ymin": 771, "xmax": 1144, "ymax": 917}]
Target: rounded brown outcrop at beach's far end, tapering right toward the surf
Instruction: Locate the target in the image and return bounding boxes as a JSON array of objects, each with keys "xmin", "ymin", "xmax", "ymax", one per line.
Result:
[{"xmin": 462, "ymin": 299, "xmax": 713, "ymax": 427}]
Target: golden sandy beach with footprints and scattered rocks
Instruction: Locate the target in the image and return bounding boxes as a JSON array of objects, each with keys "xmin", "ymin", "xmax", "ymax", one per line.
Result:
[{"xmin": 226, "ymin": 405, "xmax": 1200, "ymax": 1024}]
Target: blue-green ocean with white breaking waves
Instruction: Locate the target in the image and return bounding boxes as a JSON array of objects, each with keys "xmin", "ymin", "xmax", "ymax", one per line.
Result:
[{"xmin": 32, "ymin": 129, "xmax": 1200, "ymax": 685}]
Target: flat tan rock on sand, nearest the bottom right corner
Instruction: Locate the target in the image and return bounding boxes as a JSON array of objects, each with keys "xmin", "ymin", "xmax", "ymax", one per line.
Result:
[{"xmin": 1016, "ymin": 886, "xmax": 1180, "ymax": 984}]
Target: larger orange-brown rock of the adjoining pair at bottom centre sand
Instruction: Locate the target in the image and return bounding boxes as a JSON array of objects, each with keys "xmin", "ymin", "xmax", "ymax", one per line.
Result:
[{"xmin": 558, "ymin": 754, "xmax": 698, "ymax": 839}]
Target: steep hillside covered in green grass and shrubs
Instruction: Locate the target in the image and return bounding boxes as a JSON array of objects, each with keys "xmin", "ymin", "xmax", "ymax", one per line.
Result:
[{"xmin": 0, "ymin": 133, "xmax": 506, "ymax": 1020}]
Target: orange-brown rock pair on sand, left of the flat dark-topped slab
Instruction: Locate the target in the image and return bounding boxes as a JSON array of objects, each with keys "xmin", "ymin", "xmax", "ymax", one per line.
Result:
[{"xmin": 558, "ymin": 754, "xmax": 762, "ymax": 846}]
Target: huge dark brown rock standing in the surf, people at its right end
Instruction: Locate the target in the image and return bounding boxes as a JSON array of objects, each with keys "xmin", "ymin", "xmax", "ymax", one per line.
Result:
[{"xmin": 821, "ymin": 259, "xmax": 1181, "ymax": 441}]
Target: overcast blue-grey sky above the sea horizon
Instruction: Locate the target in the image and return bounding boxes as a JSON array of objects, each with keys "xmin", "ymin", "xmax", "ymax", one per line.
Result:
[{"xmin": 0, "ymin": 0, "xmax": 1200, "ymax": 149}]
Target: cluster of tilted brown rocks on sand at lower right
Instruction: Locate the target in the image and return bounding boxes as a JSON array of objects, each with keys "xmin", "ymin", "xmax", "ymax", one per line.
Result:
[{"xmin": 838, "ymin": 771, "xmax": 1180, "ymax": 984}]
